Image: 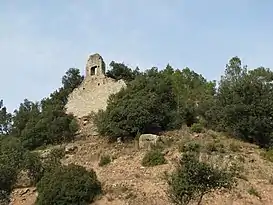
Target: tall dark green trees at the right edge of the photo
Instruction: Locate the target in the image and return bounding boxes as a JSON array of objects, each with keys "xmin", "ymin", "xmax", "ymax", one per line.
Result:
[{"xmin": 205, "ymin": 57, "xmax": 273, "ymax": 147}]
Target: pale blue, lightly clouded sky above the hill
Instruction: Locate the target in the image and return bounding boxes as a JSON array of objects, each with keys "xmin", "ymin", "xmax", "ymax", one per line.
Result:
[{"xmin": 0, "ymin": 0, "xmax": 273, "ymax": 112}]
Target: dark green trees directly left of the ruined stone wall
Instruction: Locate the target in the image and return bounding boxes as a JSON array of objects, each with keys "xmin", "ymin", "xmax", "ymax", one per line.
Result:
[{"xmin": 9, "ymin": 68, "xmax": 83, "ymax": 149}]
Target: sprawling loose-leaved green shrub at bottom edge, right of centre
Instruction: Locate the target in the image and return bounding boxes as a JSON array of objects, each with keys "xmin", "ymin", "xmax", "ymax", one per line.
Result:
[{"xmin": 168, "ymin": 154, "xmax": 235, "ymax": 205}]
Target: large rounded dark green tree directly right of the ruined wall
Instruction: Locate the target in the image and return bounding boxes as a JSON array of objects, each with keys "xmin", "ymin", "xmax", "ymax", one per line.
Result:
[{"xmin": 95, "ymin": 70, "xmax": 176, "ymax": 138}]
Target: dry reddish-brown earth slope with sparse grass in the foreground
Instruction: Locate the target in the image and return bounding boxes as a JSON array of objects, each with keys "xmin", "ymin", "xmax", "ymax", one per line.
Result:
[{"xmin": 12, "ymin": 128, "xmax": 273, "ymax": 205}]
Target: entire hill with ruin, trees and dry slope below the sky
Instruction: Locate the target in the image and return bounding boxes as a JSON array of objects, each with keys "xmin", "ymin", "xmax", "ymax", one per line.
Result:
[{"xmin": 0, "ymin": 54, "xmax": 273, "ymax": 205}]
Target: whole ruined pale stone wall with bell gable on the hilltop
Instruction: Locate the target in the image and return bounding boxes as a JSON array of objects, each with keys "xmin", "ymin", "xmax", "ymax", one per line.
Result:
[{"xmin": 66, "ymin": 53, "xmax": 126, "ymax": 119}]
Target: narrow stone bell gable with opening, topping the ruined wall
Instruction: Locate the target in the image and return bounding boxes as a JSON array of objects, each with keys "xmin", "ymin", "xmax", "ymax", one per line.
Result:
[{"xmin": 85, "ymin": 53, "xmax": 105, "ymax": 77}]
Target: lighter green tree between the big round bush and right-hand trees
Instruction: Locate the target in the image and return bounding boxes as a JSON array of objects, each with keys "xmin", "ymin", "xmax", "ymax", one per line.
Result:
[{"xmin": 159, "ymin": 64, "xmax": 215, "ymax": 127}]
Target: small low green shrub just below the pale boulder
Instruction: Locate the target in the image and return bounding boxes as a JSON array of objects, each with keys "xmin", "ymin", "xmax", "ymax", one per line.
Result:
[{"xmin": 142, "ymin": 149, "xmax": 166, "ymax": 167}]
